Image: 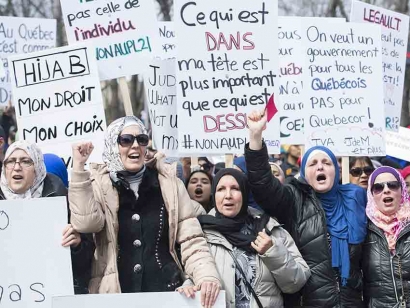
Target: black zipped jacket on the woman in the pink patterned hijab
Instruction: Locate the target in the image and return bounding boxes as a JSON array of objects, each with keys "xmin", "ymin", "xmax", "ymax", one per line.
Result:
[{"xmin": 362, "ymin": 221, "xmax": 410, "ymax": 308}]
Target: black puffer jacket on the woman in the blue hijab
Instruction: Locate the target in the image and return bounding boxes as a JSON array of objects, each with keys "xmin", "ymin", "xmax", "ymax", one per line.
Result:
[{"xmin": 245, "ymin": 144, "xmax": 363, "ymax": 308}]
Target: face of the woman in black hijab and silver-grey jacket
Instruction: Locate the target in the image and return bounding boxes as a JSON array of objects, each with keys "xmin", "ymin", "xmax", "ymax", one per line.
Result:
[{"xmin": 215, "ymin": 175, "xmax": 242, "ymax": 218}]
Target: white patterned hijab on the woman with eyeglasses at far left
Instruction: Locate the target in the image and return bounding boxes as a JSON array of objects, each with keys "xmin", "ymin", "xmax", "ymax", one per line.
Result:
[{"xmin": 0, "ymin": 141, "xmax": 47, "ymax": 200}]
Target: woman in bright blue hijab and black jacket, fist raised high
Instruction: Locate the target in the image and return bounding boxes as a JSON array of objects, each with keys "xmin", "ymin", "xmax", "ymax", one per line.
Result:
[{"xmin": 245, "ymin": 111, "xmax": 367, "ymax": 308}]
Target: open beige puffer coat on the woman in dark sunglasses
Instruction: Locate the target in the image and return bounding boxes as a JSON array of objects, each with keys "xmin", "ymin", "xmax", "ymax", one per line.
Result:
[{"xmin": 68, "ymin": 160, "xmax": 219, "ymax": 293}]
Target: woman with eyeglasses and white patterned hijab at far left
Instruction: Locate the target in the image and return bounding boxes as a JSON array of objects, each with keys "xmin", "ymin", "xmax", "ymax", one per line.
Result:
[{"xmin": 0, "ymin": 141, "xmax": 93, "ymax": 294}]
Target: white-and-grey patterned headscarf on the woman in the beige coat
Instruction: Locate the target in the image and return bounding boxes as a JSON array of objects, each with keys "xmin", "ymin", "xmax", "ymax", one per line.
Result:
[{"xmin": 103, "ymin": 116, "xmax": 147, "ymax": 200}]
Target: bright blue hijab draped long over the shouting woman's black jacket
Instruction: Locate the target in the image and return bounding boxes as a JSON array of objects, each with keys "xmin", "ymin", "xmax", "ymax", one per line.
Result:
[{"xmin": 300, "ymin": 146, "xmax": 367, "ymax": 286}]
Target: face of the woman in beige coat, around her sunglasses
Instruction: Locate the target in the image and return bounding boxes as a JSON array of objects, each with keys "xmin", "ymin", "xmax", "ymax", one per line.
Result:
[{"xmin": 118, "ymin": 125, "xmax": 146, "ymax": 172}]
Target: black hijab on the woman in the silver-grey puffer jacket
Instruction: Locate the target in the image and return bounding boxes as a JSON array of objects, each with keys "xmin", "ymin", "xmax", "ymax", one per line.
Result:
[{"xmin": 198, "ymin": 168, "xmax": 269, "ymax": 253}]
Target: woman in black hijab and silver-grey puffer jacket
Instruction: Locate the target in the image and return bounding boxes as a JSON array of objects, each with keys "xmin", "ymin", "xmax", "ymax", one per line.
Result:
[{"xmin": 179, "ymin": 169, "xmax": 310, "ymax": 308}]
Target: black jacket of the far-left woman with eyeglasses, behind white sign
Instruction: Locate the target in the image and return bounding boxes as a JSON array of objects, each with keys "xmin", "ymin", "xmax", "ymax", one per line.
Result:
[{"xmin": 0, "ymin": 173, "xmax": 94, "ymax": 294}]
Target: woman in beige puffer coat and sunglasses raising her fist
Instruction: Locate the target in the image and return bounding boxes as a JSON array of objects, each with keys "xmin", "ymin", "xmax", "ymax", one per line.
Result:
[{"xmin": 69, "ymin": 116, "xmax": 220, "ymax": 307}]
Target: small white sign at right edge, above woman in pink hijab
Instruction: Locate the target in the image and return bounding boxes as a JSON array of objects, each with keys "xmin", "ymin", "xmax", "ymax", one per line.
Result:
[{"xmin": 386, "ymin": 127, "xmax": 410, "ymax": 161}]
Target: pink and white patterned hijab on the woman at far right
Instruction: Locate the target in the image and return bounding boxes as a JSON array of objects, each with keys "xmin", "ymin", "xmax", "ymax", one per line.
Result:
[{"xmin": 366, "ymin": 167, "xmax": 410, "ymax": 251}]
